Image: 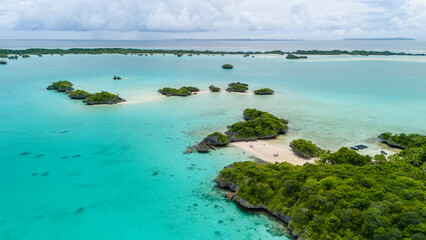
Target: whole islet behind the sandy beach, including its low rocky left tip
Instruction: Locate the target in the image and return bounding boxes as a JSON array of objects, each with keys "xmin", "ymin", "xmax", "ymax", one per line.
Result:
[{"xmin": 195, "ymin": 109, "xmax": 288, "ymax": 153}]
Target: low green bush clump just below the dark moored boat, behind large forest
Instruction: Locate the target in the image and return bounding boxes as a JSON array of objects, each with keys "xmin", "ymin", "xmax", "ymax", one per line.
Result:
[{"xmin": 320, "ymin": 147, "xmax": 371, "ymax": 166}]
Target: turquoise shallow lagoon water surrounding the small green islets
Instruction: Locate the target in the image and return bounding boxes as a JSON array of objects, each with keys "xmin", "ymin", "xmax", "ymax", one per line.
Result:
[{"xmin": 0, "ymin": 55, "xmax": 426, "ymax": 239}]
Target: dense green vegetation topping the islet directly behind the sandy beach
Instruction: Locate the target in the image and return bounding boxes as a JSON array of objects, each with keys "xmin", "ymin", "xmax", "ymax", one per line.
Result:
[{"xmin": 226, "ymin": 109, "xmax": 288, "ymax": 141}]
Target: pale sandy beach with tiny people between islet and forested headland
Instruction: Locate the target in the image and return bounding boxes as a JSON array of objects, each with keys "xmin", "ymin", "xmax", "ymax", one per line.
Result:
[{"xmin": 230, "ymin": 140, "xmax": 314, "ymax": 165}]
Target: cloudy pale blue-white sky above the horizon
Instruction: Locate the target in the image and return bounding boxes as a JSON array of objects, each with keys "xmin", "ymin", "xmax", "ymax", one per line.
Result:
[{"xmin": 0, "ymin": 0, "xmax": 426, "ymax": 40}]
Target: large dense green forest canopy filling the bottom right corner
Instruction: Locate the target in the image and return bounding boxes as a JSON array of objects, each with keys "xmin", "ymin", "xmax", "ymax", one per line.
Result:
[{"xmin": 217, "ymin": 160, "xmax": 426, "ymax": 240}]
